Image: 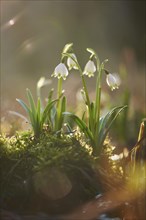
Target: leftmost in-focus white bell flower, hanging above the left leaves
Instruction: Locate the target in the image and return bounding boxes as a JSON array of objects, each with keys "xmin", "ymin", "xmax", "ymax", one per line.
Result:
[{"xmin": 52, "ymin": 63, "xmax": 68, "ymax": 80}]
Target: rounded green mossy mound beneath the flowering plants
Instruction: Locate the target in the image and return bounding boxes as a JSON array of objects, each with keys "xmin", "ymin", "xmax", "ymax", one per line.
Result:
[{"xmin": 0, "ymin": 131, "xmax": 99, "ymax": 213}]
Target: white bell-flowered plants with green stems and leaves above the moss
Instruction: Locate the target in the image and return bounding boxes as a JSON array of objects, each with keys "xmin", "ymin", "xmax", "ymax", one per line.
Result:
[{"xmin": 17, "ymin": 43, "xmax": 126, "ymax": 156}]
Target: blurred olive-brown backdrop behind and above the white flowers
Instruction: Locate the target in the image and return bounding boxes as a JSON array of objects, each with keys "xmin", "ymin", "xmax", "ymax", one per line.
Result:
[{"xmin": 0, "ymin": 0, "xmax": 146, "ymax": 143}]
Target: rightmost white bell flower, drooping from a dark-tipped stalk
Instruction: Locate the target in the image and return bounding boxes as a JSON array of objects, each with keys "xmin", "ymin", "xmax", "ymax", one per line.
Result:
[{"xmin": 106, "ymin": 73, "xmax": 121, "ymax": 91}]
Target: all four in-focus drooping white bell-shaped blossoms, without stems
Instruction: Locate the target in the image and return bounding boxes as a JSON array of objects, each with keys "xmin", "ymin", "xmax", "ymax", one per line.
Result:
[{"xmin": 52, "ymin": 50, "xmax": 121, "ymax": 91}]
